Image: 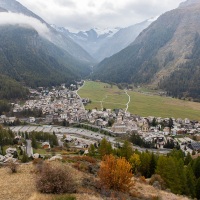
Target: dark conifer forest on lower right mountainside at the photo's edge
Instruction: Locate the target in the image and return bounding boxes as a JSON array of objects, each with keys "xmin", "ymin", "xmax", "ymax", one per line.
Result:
[{"xmin": 160, "ymin": 33, "xmax": 200, "ymax": 101}]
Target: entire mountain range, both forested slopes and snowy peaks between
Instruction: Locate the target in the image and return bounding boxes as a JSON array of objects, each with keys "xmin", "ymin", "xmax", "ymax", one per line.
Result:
[{"xmin": 0, "ymin": 0, "xmax": 200, "ymax": 101}]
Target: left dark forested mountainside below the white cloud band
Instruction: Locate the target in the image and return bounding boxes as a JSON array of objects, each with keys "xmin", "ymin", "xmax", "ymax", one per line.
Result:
[{"xmin": 0, "ymin": 26, "xmax": 85, "ymax": 87}]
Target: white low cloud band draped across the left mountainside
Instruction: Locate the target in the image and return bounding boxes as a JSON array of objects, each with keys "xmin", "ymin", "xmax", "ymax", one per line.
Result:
[{"xmin": 0, "ymin": 12, "xmax": 50, "ymax": 39}]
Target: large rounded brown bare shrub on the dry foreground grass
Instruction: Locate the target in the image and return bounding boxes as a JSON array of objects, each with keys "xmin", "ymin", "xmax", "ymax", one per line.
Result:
[{"xmin": 36, "ymin": 162, "xmax": 76, "ymax": 194}]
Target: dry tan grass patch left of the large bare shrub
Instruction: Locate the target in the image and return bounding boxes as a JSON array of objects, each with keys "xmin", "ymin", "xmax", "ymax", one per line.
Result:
[{"xmin": 0, "ymin": 164, "xmax": 83, "ymax": 200}]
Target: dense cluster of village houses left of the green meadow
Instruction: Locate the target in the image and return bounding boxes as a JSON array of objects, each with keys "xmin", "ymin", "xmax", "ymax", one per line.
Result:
[{"xmin": 13, "ymin": 86, "xmax": 87, "ymax": 124}]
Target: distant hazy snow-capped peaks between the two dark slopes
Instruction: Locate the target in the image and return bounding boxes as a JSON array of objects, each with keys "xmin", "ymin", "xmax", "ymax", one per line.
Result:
[{"xmin": 52, "ymin": 19, "xmax": 155, "ymax": 61}]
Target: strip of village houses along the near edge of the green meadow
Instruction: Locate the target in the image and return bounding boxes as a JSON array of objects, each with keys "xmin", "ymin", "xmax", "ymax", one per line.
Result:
[{"xmin": 88, "ymin": 109, "xmax": 200, "ymax": 135}]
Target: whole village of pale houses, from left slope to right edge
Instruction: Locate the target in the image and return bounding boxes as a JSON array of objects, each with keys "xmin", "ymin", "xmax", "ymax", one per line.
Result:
[{"xmin": 0, "ymin": 83, "xmax": 200, "ymax": 153}]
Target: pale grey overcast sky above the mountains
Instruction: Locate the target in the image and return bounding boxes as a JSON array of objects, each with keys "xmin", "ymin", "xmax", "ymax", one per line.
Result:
[{"xmin": 18, "ymin": 0, "xmax": 185, "ymax": 31}]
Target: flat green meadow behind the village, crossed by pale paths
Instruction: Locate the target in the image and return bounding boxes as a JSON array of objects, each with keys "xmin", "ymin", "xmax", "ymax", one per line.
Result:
[{"xmin": 78, "ymin": 81, "xmax": 200, "ymax": 120}]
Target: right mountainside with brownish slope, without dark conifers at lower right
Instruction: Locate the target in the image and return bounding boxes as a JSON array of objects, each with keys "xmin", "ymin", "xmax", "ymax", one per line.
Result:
[{"xmin": 93, "ymin": 1, "xmax": 200, "ymax": 98}]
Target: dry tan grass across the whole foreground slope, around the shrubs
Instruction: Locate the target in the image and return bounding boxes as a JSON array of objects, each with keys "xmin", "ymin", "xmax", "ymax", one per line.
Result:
[{"xmin": 0, "ymin": 163, "xmax": 191, "ymax": 200}]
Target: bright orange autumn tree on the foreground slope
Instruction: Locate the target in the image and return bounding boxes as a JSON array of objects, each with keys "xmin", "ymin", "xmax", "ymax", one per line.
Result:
[{"xmin": 99, "ymin": 155, "xmax": 133, "ymax": 192}]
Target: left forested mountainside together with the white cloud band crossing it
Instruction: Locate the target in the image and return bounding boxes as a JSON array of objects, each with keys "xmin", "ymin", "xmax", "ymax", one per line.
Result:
[{"xmin": 0, "ymin": 0, "xmax": 94, "ymax": 87}]
